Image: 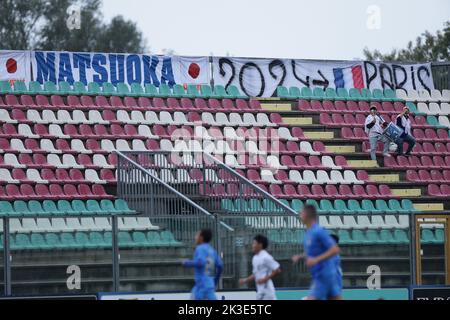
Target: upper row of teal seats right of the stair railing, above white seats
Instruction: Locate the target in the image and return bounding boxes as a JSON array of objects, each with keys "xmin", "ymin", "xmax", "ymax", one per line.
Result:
[{"xmin": 221, "ymin": 199, "xmax": 416, "ymax": 215}]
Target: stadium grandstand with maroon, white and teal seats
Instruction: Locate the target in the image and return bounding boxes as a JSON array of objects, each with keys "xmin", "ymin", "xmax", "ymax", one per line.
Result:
[{"xmin": 0, "ymin": 53, "xmax": 450, "ymax": 296}]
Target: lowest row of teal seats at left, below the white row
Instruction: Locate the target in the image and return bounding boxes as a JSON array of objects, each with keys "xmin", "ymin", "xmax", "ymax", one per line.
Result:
[{"xmin": 1, "ymin": 231, "xmax": 182, "ymax": 251}]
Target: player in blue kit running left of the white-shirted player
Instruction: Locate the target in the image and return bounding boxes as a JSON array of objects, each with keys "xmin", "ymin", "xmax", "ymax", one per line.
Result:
[{"xmin": 183, "ymin": 229, "xmax": 223, "ymax": 300}]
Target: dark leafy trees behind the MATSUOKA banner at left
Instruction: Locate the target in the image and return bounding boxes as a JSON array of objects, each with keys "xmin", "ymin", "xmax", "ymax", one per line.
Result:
[{"xmin": 0, "ymin": 0, "xmax": 146, "ymax": 53}]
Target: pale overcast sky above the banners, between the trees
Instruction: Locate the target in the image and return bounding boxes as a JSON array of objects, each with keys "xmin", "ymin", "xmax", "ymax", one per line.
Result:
[{"xmin": 103, "ymin": 0, "xmax": 450, "ymax": 60}]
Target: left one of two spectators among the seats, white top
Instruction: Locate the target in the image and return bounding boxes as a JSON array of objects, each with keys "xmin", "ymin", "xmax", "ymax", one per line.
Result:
[{"xmin": 364, "ymin": 106, "xmax": 390, "ymax": 161}]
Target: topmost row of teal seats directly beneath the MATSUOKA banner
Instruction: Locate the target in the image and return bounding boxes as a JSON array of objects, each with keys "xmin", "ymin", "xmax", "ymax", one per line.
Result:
[{"xmin": 0, "ymin": 81, "xmax": 246, "ymax": 99}]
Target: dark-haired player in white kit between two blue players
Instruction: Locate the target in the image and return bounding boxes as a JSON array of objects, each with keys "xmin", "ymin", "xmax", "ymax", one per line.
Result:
[{"xmin": 239, "ymin": 235, "xmax": 281, "ymax": 300}]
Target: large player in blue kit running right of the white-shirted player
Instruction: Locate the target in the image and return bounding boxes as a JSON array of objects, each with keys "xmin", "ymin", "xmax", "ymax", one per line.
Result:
[{"xmin": 292, "ymin": 205, "xmax": 342, "ymax": 300}]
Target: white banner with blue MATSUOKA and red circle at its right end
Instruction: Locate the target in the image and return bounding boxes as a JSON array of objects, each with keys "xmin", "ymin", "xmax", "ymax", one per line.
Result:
[{"xmin": 31, "ymin": 51, "xmax": 210, "ymax": 87}]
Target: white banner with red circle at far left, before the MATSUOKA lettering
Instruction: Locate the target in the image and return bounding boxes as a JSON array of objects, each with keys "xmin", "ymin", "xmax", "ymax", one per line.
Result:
[{"xmin": 0, "ymin": 51, "xmax": 30, "ymax": 83}]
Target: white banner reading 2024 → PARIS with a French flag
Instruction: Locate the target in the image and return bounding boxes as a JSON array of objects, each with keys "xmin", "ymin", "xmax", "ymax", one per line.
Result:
[{"xmin": 213, "ymin": 57, "xmax": 434, "ymax": 97}]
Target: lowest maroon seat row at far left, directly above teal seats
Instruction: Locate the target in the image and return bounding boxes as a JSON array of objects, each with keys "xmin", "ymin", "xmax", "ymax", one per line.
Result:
[{"xmin": 0, "ymin": 183, "xmax": 114, "ymax": 201}]
